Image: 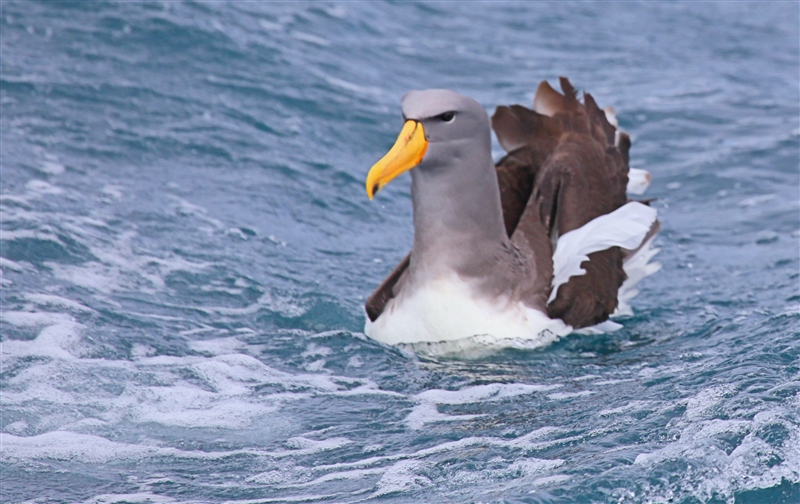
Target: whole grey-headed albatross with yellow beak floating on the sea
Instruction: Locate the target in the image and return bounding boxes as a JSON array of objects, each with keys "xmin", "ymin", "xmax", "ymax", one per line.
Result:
[{"xmin": 364, "ymin": 77, "xmax": 659, "ymax": 349}]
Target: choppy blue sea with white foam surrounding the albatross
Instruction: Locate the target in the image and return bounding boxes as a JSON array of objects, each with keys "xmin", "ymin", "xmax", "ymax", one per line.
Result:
[{"xmin": 0, "ymin": 1, "xmax": 800, "ymax": 503}]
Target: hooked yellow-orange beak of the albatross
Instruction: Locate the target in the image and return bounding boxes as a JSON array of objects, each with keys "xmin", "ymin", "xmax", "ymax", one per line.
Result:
[{"xmin": 367, "ymin": 120, "xmax": 428, "ymax": 199}]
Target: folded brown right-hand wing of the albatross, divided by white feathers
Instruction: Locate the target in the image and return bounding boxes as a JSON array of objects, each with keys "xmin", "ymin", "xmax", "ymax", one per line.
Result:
[{"xmin": 532, "ymin": 78, "xmax": 630, "ymax": 328}]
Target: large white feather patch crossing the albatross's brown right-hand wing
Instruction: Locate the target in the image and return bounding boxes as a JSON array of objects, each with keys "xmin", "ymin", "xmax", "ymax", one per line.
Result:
[{"xmin": 547, "ymin": 201, "xmax": 658, "ymax": 304}]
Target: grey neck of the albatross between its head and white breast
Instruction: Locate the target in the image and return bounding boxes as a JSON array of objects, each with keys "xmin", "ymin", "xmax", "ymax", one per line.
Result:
[{"xmin": 410, "ymin": 143, "xmax": 508, "ymax": 281}]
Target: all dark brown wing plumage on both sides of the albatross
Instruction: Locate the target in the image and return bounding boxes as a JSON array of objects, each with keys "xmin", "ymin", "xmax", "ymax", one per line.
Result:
[{"xmin": 366, "ymin": 77, "xmax": 630, "ymax": 328}]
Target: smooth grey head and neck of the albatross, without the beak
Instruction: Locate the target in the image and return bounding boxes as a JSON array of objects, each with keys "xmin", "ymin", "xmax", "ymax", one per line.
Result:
[{"xmin": 402, "ymin": 89, "xmax": 508, "ymax": 280}]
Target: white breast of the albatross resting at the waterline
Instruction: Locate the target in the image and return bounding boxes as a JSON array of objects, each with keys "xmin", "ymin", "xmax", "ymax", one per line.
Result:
[{"xmin": 364, "ymin": 274, "xmax": 572, "ymax": 345}]
